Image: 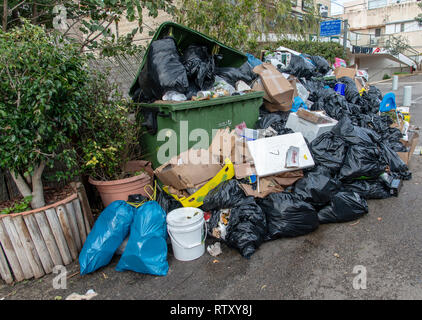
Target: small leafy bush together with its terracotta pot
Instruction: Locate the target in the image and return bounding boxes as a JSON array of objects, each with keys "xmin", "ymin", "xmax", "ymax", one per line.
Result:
[{"xmin": 78, "ymin": 72, "xmax": 154, "ymax": 207}]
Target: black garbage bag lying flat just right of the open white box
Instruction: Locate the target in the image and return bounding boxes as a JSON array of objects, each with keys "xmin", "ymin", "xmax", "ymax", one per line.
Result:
[{"xmin": 331, "ymin": 117, "xmax": 381, "ymax": 146}]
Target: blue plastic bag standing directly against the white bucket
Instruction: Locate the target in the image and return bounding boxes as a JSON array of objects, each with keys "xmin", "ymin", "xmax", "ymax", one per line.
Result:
[{"xmin": 116, "ymin": 201, "xmax": 169, "ymax": 276}]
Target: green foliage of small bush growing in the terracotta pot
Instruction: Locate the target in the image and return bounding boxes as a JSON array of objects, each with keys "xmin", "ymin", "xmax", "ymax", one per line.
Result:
[{"xmin": 77, "ymin": 71, "xmax": 140, "ymax": 181}]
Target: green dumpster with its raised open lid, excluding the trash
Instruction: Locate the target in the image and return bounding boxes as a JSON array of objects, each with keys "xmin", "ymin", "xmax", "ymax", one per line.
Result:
[{"xmin": 129, "ymin": 22, "xmax": 264, "ymax": 168}]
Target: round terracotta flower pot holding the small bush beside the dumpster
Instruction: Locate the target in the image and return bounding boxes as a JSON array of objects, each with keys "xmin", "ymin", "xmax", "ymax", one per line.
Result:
[{"xmin": 88, "ymin": 160, "xmax": 154, "ymax": 207}]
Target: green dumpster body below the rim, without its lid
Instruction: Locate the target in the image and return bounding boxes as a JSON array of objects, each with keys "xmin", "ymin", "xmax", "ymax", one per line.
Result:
[{"xmin": 138, "ymin": 91, "xmax": 264, "ymax": 168}]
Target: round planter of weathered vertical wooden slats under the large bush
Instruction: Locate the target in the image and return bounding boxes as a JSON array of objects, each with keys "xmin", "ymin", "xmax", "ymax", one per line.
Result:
[{"xmin": 0, "ymin": 183, "xmax": 94, "ymax": 283}]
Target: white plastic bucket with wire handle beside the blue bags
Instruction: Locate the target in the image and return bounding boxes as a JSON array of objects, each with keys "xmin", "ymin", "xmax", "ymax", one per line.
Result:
[{"xmin": 167, "ymin": 207, "xmax": 207, "ymax": 261}]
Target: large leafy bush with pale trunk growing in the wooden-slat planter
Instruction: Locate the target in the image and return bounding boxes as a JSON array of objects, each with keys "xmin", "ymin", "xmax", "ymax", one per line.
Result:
[{"xmin": 0, "ymin": 21, "xmax": 88, "ymax": 209}]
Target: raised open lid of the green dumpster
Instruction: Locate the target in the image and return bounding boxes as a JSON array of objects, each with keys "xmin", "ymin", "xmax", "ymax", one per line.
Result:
[{"xmin": 129, "ymin": 21, "xmax": 248, "ymax": 97}]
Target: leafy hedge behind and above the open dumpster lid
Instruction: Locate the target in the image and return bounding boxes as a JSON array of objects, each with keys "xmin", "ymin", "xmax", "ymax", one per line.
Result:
[{"xmin": 175, "ymin": 0, "xmax": 316, "ymax": 51}]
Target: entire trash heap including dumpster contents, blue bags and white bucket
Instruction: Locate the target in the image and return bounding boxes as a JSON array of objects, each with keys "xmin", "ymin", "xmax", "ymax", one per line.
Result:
[{"xmin": 79, "ymin": 24, "xmax": 419, "ymax": 275}]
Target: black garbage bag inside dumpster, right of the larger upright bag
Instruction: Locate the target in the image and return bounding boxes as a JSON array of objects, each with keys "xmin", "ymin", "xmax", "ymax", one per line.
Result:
[{"xmin": 182, "ymin": 44, "xmax": 215, "ymax": 91}]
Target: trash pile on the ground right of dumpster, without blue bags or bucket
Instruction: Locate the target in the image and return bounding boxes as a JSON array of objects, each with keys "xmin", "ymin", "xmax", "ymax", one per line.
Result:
[{"xmin": 149, "ymin": 46, "xmax": 419, "ymax": 258}]
